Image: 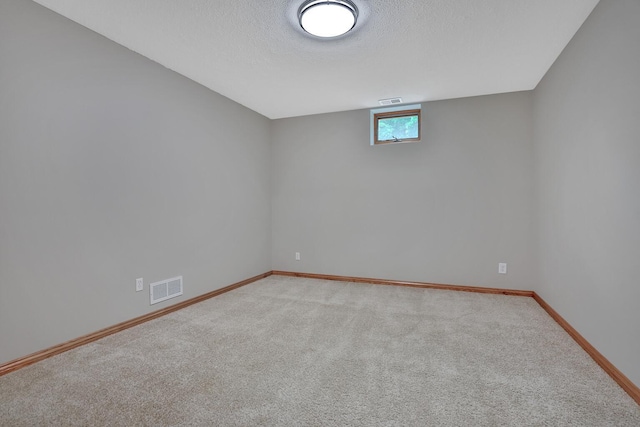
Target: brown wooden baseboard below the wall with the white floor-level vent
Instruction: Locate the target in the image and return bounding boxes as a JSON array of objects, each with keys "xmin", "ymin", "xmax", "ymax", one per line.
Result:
[{"xmin": 0, "ymin": 271, "xmax": 271, "ymax": 376}]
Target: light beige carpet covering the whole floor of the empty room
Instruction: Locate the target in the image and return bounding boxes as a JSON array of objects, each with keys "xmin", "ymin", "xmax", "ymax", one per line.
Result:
[{"xmin": 0, "ymin": 276, "xmax": 640, "ymax": 427}]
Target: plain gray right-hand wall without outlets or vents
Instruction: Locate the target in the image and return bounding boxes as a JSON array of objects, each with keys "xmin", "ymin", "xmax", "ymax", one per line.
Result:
[{"xmin": 534, "ymin": 0, "xmax": 640, "ymax": 384}]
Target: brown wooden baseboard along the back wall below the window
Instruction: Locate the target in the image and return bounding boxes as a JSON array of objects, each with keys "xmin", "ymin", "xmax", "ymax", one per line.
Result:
[{"xmin": 271, "ymin": 270, "xmax": 533, "ymax": 297}]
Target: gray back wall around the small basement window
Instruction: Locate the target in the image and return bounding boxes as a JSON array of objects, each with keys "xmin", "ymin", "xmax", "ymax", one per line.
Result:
[{"xmin": 272, "ymin": 92, "xmax": 535, "ymax": 289}]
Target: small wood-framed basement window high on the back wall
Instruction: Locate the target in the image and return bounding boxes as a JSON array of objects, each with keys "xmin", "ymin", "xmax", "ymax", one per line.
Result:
[{"xmin": 371, "ymin": 104, "xmax": 422, "ymax": 145}]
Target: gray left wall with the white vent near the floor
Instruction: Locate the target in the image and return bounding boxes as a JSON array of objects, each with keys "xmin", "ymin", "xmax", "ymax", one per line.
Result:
[{"xmin": 0, "ymin": 0, "xmax": 271, "ymax": 363}]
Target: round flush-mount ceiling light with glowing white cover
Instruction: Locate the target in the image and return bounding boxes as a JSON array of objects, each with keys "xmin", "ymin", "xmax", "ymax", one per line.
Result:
[{"xmin": 298, "ymin": 0, "xmax": 358, "ymax": 38}]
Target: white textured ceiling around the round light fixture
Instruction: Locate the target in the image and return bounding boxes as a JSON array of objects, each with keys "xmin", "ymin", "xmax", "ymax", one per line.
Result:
[{"xmin": 36, "ymin": 0, "xmax": 598, "ymax": 119}]
